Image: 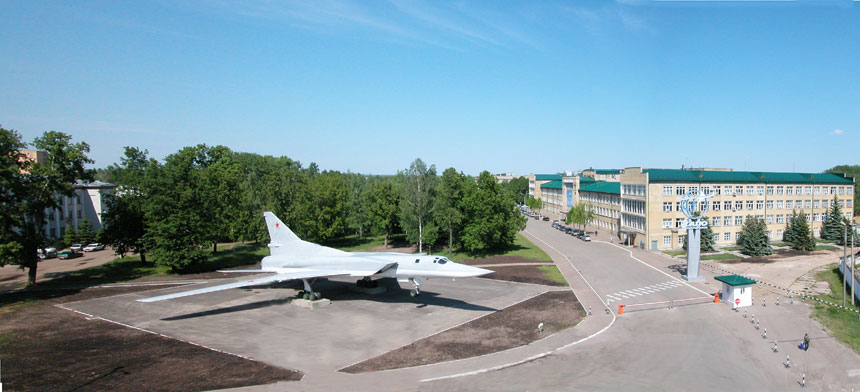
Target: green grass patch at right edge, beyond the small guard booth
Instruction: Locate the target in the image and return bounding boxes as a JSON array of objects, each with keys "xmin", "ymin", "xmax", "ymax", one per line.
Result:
[{"xmin": 812, "ymin": 264, "xmax": 860, "ymax": 353}]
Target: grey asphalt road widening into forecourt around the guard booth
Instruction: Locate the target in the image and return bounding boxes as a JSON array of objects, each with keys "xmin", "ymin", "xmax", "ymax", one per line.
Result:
[{"xmin": 421, "ymin": 221, "xmax": 860, "ymax": 391}]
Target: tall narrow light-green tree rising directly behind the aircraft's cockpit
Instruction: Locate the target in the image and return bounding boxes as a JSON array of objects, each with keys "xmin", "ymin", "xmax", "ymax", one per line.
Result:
[{"xmin": 398, "ymin": 158, "xmax": 436, "ymax": 253}]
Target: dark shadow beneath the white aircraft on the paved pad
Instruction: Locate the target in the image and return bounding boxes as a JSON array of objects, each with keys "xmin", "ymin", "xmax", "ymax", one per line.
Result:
[{"xmin": 161, "ymin": 279, "xmax": 498, "ymax": 321}]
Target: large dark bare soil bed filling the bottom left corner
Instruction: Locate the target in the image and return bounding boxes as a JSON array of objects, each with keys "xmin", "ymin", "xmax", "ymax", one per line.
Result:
[{"xmin": 0, "ymin": 287, "xmax": 302, "ymax": 391}]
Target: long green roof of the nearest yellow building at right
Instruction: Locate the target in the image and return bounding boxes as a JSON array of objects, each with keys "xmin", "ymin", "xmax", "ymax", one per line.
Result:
[{"xmin": 643, "ymin": 169, "xmax": 854, "ymax": 185}]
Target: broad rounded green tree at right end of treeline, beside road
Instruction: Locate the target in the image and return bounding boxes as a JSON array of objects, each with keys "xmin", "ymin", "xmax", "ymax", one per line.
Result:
[{"xmin": 462, "ymin": 171, "xmax": 526, "ymax": 252}]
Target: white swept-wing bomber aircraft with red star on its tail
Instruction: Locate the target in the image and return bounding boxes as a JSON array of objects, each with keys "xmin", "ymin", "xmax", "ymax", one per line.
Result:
[{"xmin": 137, "ymin": 212, "xmax": 493, "ymax": 302}]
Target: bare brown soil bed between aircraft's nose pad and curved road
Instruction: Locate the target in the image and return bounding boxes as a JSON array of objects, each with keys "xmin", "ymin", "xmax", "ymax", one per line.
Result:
[{"xmin": 341, "ymin": 290, "xmax": 585, "ymax": 373}]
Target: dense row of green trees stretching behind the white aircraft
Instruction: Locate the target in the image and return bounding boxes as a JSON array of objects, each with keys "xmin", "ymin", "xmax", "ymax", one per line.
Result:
[{"xmin": 96, "ymin": 145, "xmax": 528, "ymax": 270}]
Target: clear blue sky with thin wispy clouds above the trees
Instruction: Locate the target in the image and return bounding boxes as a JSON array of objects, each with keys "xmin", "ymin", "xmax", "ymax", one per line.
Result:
[{"xmin": 0, "ymin": 0, "xmax": 860, "ymax": 174}]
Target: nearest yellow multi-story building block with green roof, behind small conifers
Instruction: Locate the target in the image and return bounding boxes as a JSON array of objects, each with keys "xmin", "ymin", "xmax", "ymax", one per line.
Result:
[{"xmin": 620, "ymin": 167, "xmax": 854, "ymax": 249}]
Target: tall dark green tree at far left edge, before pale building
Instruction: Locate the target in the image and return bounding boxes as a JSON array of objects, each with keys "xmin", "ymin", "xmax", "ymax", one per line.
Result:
[{"xmin": 0, "ymin": 128, "xmax": 93, "ymax": 285}]
